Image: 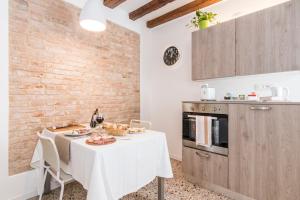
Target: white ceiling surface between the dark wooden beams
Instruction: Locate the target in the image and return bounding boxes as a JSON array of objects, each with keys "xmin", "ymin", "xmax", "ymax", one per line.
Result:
[{"xmin": 65, "ymin": 0, "xmax": 289, "ymax": 27}]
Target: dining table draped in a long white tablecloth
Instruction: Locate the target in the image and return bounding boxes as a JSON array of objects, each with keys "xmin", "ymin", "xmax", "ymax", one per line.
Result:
[{"xmin": 31, "ymin": 129, "xmax": 173, "ymax": 200}]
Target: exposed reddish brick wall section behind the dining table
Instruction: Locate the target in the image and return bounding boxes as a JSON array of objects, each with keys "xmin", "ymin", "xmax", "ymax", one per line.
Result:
[{"xmin": 9, "ymin": 0, "xmax": 140, "ymax": 175}]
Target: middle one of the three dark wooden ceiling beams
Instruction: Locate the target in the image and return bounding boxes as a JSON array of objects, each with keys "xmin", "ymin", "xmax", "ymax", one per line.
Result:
[{"xmin": 129, "ymin": 0, "xmax": 174, "ymax": 20}]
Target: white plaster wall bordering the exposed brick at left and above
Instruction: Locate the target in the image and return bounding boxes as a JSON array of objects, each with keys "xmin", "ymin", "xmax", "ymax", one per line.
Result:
[{"xmin": 0, "ymin": 0, "xmax": 144, "ymax": 200}]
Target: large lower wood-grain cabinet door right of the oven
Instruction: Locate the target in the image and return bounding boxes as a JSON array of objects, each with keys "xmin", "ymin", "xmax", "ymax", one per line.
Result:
[{"xmin": 229, "ymin": 105, "xmax": 300, "ymax": 200}]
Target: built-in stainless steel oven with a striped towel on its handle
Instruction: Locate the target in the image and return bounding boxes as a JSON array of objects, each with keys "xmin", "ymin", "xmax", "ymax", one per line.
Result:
[{"xmin": 182, "ymin": 103, "xmax": 228, "ymax": 155}]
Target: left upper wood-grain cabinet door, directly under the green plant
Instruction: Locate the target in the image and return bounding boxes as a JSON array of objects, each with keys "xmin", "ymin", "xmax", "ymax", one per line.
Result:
[{"xmin": 192, "ymin": 20, "xmax": 235, "ymax": 80}]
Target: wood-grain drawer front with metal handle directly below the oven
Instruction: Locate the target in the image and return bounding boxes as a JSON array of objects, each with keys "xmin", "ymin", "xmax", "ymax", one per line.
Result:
[{"xmin": 182, "ymin": 147, "xmax": 228, "ymax": 188}]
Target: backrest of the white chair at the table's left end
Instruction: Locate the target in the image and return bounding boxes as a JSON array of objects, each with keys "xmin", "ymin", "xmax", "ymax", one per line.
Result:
[{"xmin": 38, "ymin": 133, "xmax": 60, "ymax": 176}]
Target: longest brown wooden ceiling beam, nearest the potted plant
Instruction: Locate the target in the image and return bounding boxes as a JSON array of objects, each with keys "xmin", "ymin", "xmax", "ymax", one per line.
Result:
[{"xmin": 147, "ymin": 0, "xmax": 221, "ymax": 28}]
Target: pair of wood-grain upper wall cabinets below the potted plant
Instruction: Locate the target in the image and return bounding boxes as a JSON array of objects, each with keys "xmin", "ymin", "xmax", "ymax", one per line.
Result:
[{"xmin": 192, "ymin": 0, "xmax": 300, "ymax": 80}]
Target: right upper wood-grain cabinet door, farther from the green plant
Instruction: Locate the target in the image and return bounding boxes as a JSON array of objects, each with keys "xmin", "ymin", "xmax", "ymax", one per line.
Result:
[{"xmin": 236, "ymin": 1, "xmax": 300, "ymax": 75}]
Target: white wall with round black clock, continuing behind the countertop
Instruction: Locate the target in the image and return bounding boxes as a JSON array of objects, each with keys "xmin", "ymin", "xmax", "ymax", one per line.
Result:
[{"xmin": 141, "ymin": 4, "xmax": 300, "ymax": 160}]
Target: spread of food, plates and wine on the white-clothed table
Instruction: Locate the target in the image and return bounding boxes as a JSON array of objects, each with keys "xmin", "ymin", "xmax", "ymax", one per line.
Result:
[{"xmin": 47, "ymin": 108, "xmax": 151, "ymax": 149}]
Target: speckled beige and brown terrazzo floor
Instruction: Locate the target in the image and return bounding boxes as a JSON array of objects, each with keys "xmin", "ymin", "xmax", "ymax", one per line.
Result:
[{"xmin": 31, "ymin": 160, "xmax": 230, "ymax": 200}]
